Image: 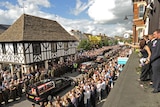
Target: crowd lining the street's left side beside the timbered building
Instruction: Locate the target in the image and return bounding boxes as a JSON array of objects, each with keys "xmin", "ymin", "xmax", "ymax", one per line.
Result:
[{"xmin": 0, "ymin": 52, "xmax": 91, "ymax": 105}]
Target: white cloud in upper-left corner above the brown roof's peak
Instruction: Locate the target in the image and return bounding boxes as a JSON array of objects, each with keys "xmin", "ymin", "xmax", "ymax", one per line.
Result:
[{"xmin": 0, "ymin": 0, "xmax": 54, "ymax": 24}]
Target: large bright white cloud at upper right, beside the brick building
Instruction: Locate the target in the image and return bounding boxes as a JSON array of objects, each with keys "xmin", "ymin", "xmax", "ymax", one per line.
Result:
[{"xmin": 69, "ymin": 0, "xmax": 133, "ymax": 36}]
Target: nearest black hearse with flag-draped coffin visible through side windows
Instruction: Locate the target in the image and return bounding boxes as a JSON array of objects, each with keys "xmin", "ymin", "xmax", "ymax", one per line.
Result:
[{"xmin": 26, "ymin": 77, "xmax": 74, "ymax": 104}]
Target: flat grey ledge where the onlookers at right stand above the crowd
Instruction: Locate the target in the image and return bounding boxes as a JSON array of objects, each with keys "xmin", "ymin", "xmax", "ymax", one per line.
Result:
[{"xmin": 101, "ymin": 52, "xmax": 160, "ymax": 107}]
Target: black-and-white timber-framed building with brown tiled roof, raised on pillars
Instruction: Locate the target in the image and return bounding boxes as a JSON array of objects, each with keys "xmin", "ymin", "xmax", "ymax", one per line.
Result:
[{"xmin": 0, "ymin": 14, "xmax": 77, "ymax": 76}]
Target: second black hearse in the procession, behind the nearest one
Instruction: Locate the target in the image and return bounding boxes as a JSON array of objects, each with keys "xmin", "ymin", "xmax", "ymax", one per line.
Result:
[{"xmin": 80, "ymin": 61, "xmax": 98, "ymax": 73}]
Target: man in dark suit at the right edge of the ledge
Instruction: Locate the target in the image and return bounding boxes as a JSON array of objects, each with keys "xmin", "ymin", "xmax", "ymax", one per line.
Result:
[{"xmin": 150, "ymin": 29, "xmax": 160, "ymax": 93}]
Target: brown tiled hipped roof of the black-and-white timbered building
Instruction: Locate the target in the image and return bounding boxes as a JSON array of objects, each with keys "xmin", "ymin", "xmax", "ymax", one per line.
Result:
[{"xmin": 0, "ymin": 14, "xmax": 77, "ymax": 42}]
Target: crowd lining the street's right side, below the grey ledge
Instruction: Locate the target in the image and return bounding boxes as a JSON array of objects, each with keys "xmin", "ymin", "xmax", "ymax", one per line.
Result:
[{"xmin": 43, "ymin": 46, "xmax": 130, "ymax": 107}]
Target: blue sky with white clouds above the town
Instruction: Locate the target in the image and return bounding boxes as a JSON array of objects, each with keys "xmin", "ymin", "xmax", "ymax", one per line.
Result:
[{"xmin": 0, "ymin": 0, "xmax": 133, "ymax": 36}]
